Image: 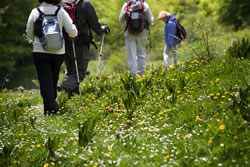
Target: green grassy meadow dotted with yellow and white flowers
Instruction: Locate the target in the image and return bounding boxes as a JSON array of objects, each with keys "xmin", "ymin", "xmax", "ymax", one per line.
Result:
[{"xmin": 0, "ymin": 45, "xmax": 250, "ymax": 167}]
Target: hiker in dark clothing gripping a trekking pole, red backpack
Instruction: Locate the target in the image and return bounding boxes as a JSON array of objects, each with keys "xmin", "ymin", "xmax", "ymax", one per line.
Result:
[{"xmin": 58, "ymin": 0, "xmax": 108, "ymax": 97}]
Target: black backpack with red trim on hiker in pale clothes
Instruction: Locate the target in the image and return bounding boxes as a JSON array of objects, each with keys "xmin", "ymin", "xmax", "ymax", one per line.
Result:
[{"xmin": 125, "ymin": 0, "xmax": 144, "ymax": 33}]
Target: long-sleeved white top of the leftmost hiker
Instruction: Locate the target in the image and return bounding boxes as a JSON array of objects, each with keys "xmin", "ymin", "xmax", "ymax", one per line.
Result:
[{"xmin": 26, "ymin": 2, "xmax": 77, "ymax": 54}]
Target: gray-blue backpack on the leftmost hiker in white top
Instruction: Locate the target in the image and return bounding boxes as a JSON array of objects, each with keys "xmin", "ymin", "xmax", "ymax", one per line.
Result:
[{"xmin": 37, "ymin": 6, "xmax": 63, "ymax": 51}]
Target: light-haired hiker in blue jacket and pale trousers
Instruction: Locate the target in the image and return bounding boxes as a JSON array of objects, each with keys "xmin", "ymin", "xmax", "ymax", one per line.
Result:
[{"xmin": 158, "ymin": 11, "xmax": 180, "ymax": 67}]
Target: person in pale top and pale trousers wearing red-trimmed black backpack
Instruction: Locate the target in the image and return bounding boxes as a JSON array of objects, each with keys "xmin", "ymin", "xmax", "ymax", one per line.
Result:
[{"xmin": 119, "ymin": 0, "xmax": 154, "ymax": 76}]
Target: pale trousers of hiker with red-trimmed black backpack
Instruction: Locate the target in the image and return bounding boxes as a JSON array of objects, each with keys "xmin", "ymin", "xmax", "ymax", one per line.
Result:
[{"xmin": 126, "ymin": 37, "xmax": 147, "ymax": 76}]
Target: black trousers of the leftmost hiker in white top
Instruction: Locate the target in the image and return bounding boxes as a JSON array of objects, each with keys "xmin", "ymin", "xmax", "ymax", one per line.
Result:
[{"xmin": 33, "ymin": 53, "xmax": 64, "ymax": 113}]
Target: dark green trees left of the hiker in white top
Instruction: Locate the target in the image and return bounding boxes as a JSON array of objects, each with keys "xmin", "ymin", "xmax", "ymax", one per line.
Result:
[{"xmin": 0, "ymin": 0, "xmax": 37, "ymax": 85}]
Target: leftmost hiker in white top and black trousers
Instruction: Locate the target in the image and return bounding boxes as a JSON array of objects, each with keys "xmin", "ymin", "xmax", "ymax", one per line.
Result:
[{"xmin": 26, "ymin": 0, "xmax": 77, "ymax": 115}]
